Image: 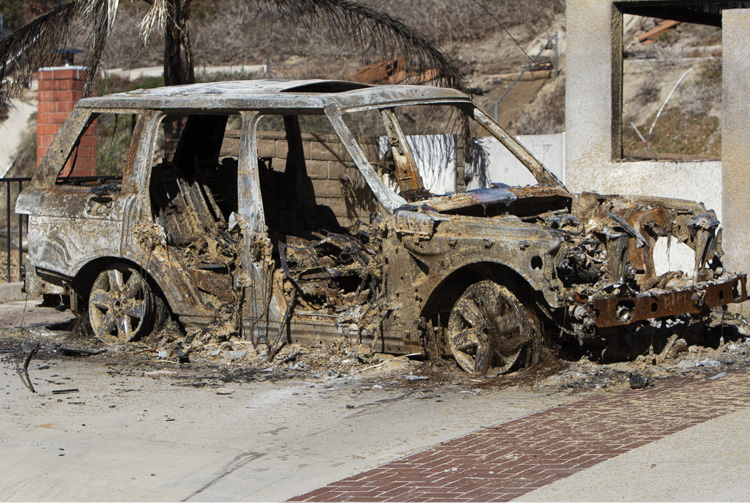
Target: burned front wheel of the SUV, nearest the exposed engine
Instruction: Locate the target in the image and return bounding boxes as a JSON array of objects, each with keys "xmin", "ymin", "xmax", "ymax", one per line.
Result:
[{"xmin": 448, "ymin": 280, "xmax": 542, "ymax": 374}]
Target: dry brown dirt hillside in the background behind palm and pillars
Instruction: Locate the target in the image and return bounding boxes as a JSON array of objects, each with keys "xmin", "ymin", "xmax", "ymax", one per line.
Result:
[{"xmin": 0, "ymin": 0, "xmax": 721, "ymax": 169}]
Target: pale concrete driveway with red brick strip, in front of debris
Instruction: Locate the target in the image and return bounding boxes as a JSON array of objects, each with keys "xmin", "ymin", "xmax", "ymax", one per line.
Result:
[{"xmin": 0, "ymin": 302, "xmax": 750, "ymax": 501}]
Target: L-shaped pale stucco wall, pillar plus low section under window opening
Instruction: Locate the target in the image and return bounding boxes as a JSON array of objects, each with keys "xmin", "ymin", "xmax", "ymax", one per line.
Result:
[{"xmin": 565, "ymin": 0, "xmax": 726, "ymax": 218}]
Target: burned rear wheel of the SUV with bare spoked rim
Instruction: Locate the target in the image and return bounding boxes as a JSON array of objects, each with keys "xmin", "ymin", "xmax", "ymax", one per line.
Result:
[{"xmin": 88, "ymin": 264, "xmax": 155, "ymax": 344}]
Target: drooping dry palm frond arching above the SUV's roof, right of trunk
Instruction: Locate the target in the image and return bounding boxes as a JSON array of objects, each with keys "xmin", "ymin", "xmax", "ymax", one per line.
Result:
[{"xmin": 261, "ymin": 0, "xmax": 467, "ymax": 91}]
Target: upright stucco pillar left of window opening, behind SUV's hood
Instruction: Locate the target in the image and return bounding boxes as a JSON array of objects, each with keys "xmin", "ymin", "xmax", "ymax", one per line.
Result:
[{"xmin": 565, "ymin": 0, "xmax": 622, "ymax": 191}]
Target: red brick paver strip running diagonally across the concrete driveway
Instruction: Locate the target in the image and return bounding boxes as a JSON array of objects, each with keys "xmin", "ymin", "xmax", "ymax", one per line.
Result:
[{"xmin": 292, "ymin": 370, "xmax": 750, "ymax": 501}]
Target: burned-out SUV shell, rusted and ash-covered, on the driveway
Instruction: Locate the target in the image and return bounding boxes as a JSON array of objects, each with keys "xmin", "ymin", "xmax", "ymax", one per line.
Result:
[{"xmin": 16, "ymin": 81, "xmax": 746, "ymax": 373}]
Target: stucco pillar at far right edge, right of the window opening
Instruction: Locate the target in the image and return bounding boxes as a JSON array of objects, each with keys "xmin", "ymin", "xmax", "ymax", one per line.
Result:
[{"xmin": 721, "ymin": 9, "xmax": 750, "ymax": 314}]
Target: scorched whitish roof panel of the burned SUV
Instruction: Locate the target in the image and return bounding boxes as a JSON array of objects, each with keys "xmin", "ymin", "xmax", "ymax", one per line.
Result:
[{"xmin": 77, "ymin": 80, "xmax": 470, "ymax": 111}]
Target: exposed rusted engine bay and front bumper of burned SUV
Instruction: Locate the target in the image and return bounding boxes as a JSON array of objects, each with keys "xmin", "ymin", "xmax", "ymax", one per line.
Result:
[{"xmin": 528, "ymin": 189, "xmax": 745, "ymax": 331}]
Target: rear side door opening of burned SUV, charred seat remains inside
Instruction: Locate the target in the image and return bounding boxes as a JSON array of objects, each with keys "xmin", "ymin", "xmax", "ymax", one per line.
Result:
[{"xmin": 149, "ymin": 115, "xmax": 240, "ymax": 308}]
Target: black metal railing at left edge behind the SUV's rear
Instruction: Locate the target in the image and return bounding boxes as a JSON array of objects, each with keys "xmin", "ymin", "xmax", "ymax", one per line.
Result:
[{"xmin": 0, "ymin": 177, "xmax": 31, "ymax": 283}]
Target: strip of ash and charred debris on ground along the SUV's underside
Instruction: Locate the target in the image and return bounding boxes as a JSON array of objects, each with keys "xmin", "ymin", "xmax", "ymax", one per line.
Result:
[{"xmin": 0, "ymin": 306, "xmax": 750, "ymax": 397}]
